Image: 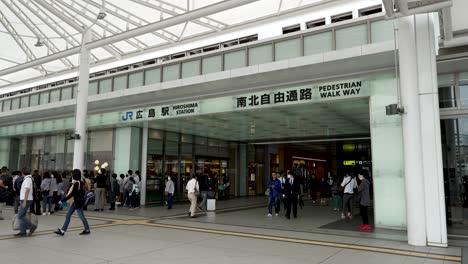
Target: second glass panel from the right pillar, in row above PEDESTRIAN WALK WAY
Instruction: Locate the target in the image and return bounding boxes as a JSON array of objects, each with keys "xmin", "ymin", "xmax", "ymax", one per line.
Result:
[{"xmin": 336, "ymin": 25, "xmax": 367, "ymax": 50}]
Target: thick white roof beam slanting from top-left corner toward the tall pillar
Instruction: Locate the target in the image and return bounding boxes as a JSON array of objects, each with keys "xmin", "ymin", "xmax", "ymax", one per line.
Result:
[{"xmin": 1, "ymin": 0, "xmax": 74, "ymax": 69}]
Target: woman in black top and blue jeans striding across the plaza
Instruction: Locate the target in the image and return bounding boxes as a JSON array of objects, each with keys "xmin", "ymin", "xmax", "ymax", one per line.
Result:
[{"xmin": 54, "ymin": 169, "xmax": 91, "ymax": 236}]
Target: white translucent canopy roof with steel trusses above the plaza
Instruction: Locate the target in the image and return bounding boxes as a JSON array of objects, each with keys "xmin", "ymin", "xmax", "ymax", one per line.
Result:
[{"xmin": 0, "ymin": 0, "xmax": 329, "ymax": 87}]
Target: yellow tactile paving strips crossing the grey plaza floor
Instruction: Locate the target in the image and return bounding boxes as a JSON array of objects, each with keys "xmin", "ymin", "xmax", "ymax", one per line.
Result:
[{"xmin": 0, "ymin": 210, "xmax": 462, "ymax": 262}]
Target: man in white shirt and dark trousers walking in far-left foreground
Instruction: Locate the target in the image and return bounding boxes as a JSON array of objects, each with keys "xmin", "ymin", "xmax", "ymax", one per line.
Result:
[{"xmin": 15, "ymin": 168, "xmax": 37, "ymax": 237}]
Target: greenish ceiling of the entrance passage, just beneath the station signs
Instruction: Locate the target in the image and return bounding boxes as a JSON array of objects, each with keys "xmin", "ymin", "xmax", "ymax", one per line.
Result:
[{"xmin": 148, "ymin": 98, "xmax": 370, "ymax": 142}]
